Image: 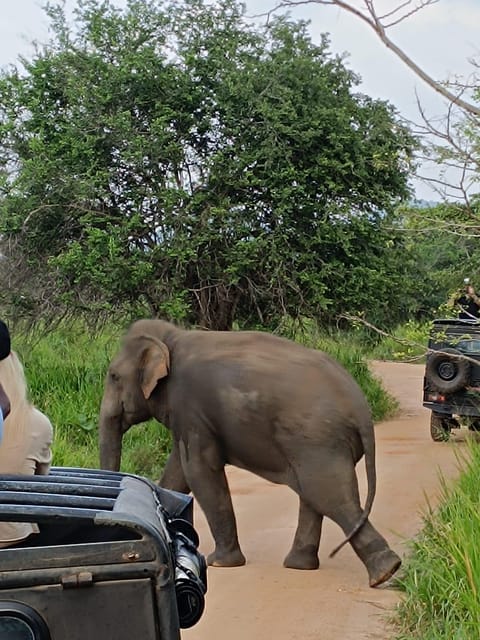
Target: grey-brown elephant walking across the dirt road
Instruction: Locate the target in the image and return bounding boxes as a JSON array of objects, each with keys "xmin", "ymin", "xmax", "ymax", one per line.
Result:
[{"xmin": 99, "ymin": 319, "xmax": 401, "ymax": 587}]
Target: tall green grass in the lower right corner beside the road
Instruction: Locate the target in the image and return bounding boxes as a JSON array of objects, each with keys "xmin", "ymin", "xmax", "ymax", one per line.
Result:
[{"xmin": 394, "ymin": 442, "xmax": 480, "ymax": 640}]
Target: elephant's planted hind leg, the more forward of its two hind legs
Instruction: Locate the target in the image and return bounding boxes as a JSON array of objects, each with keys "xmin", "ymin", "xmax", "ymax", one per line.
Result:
[{"xmin": 283, "ymin": 498, "xmax": 323, "ymax": 569}]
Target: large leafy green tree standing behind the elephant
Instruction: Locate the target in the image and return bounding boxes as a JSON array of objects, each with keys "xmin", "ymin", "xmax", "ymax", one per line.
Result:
[{"xmin": 0, "ymin": 0, "xmax": 414, "ymax": 328}]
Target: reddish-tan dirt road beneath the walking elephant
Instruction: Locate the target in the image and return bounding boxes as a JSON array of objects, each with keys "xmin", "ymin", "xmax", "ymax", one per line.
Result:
[{"xmin": 182, "ymin": 362, "xmax": 462, "ymax": 640}]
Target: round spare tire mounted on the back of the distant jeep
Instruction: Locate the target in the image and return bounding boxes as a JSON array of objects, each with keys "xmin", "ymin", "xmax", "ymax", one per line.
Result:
[{"xmin": 425, "ymin": 347, "xmax": 470, "ymax": 393}]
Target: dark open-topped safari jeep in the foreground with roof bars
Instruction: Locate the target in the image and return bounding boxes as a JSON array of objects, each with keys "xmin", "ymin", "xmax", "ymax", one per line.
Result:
[{"xmin": 0, "ymin": 468, "xmax": 206, "ymax": 640}]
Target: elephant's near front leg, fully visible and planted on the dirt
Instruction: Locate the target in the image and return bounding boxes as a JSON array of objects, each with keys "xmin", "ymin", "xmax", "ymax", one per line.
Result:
[{"xmin": 180, "ymin": 434, "xmax": 245, "ymax": 567}]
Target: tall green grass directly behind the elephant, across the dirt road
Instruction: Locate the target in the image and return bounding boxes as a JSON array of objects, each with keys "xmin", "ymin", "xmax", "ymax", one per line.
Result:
[{"xmin": 13, "ymin": 326, "xmax": 396, "ymax": 479}]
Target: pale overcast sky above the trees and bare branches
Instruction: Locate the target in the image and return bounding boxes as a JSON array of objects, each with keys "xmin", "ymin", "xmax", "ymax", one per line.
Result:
[{"xmin": 0, "ymin": 0, "xmax": 480, "ymax": 199}]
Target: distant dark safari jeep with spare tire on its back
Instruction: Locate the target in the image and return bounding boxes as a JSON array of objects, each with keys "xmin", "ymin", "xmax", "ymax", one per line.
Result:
[{"xmin": 423, "ymin": 320, "xmax": 480, "ymax": 442}]
